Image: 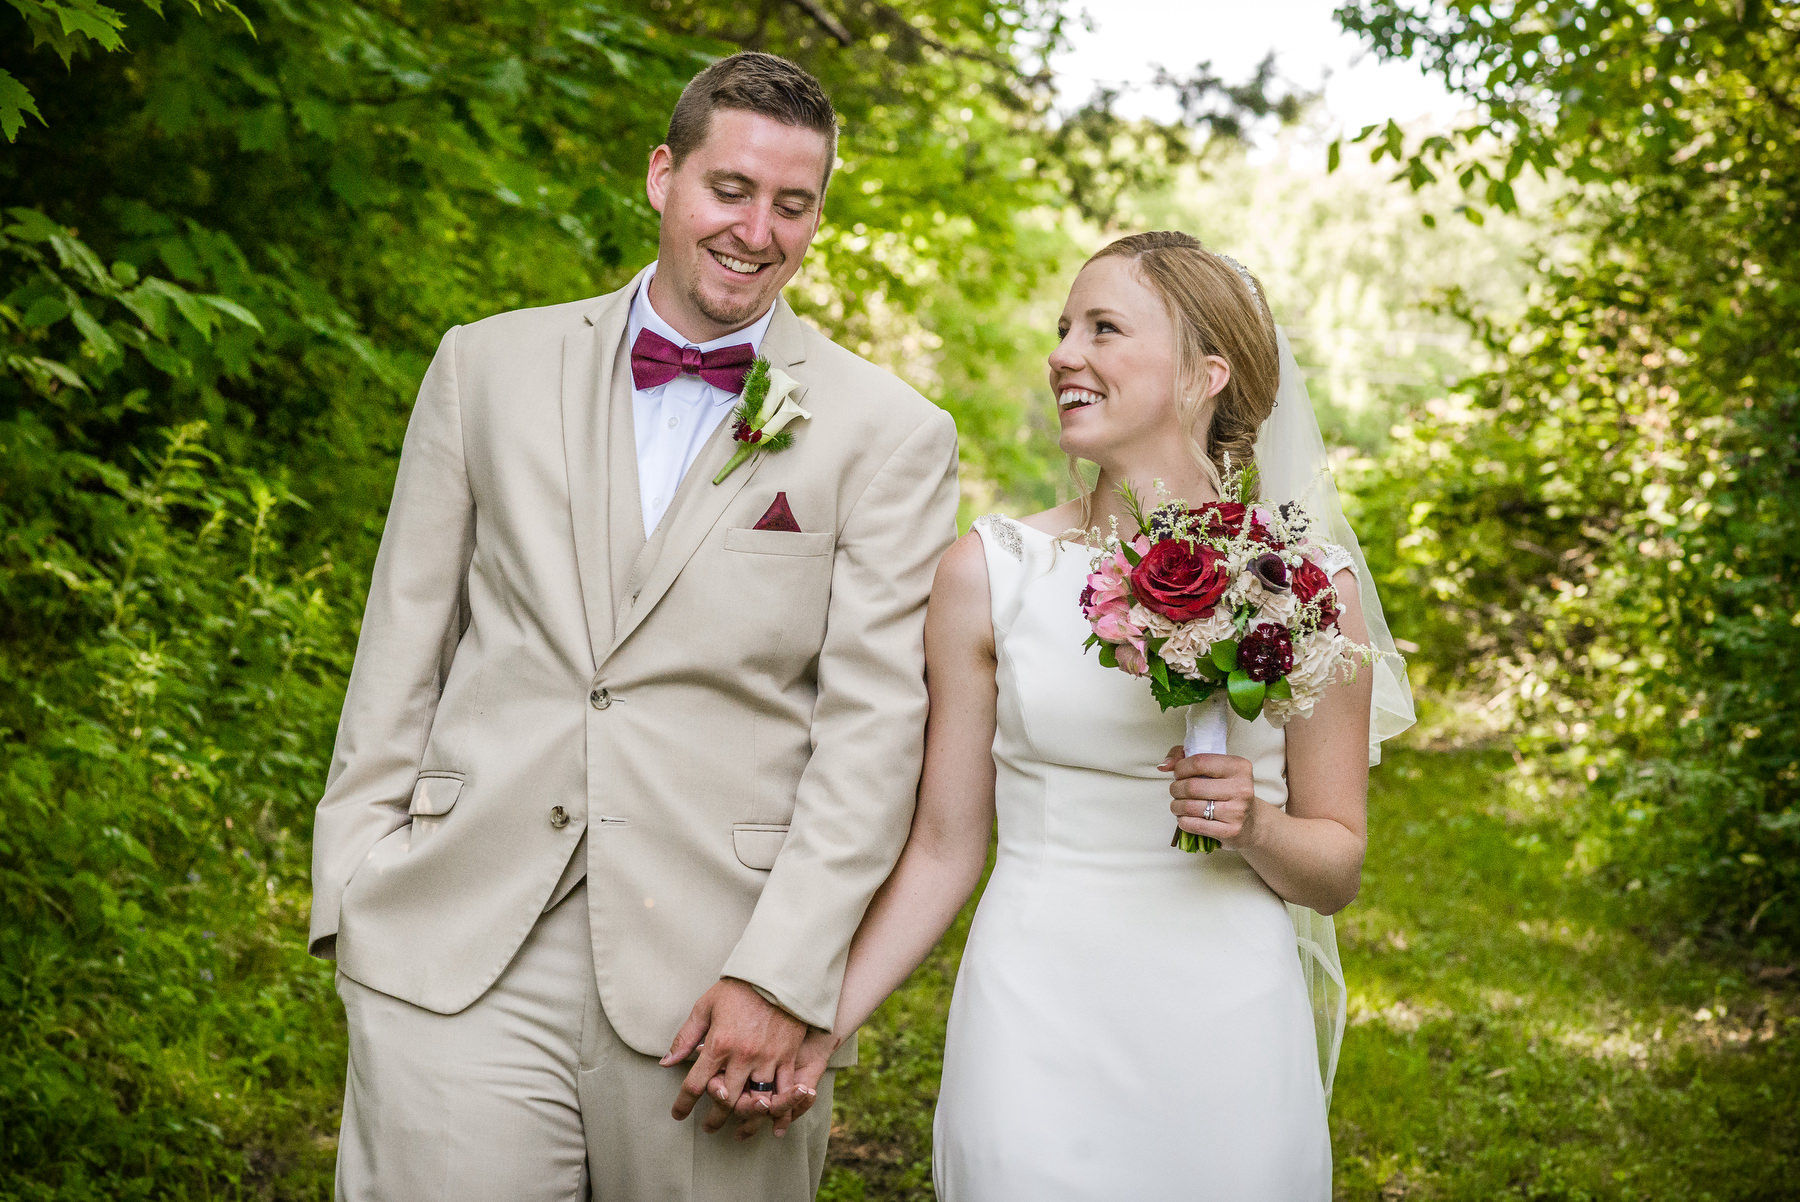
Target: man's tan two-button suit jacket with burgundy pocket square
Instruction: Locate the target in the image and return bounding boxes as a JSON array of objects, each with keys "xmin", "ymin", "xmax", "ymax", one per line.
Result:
[{"xmin": 310, "ymin": 264, "xmax": 958, "ymax": 1054}]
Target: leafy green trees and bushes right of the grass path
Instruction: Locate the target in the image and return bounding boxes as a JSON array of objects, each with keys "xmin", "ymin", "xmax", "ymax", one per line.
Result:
[{"xmin": 1339, "ymin": 0, "xmax": 1800, "ymax": 946}]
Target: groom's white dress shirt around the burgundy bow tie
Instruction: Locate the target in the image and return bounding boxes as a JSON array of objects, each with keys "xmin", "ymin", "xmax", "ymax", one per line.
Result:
[{"xmin": 625, "ymin": 265, "xmax": 776, "ymax": 538}]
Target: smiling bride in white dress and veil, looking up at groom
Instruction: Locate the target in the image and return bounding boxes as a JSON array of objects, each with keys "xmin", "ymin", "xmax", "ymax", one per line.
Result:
[{"xmin": 778, "ymin": 232, "xmax": 1411, "ymax": 1202}]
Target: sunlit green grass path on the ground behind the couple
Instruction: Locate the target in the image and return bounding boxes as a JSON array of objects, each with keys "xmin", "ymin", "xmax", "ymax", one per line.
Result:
[{"xmin": 821, "ymin": 752, "xmax": 1800, "ymax": 1202}]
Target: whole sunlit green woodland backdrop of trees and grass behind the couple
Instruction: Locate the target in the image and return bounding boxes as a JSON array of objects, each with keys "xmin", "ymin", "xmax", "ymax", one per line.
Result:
[{"xmin": 0, "ymin": 0, "xmax": 1800, "ymax": 1202}]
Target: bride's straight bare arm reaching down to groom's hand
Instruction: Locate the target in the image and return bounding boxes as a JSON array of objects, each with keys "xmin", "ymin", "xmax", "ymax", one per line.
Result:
[{"xmin": 832, "ymin": 533, "xmax": 995, "ymax": 1047}]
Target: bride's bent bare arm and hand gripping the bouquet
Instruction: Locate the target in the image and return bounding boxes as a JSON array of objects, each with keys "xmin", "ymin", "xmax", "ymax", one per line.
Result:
[{"xmin": 1172, "ymin": 570, "xmax": 1373, "ymax": 914}]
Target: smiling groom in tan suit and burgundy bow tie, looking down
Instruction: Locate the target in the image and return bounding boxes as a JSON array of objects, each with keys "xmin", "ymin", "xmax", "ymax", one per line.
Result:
[{"xmin": 310, "ymin": 54, "xmax": 958, "ymax": 1202}]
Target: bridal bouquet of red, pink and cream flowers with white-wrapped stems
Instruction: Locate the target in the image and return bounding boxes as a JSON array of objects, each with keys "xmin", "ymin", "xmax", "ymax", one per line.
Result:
[{"xmin": 1080, "ymin": 466, "xmax": 1373, "ymax": 851}]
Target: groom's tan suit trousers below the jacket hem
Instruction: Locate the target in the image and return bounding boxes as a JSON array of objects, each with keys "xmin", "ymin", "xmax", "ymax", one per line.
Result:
[{"xmin": 337, "ymin": 884, "xmax": 832, "ymax": 1202}]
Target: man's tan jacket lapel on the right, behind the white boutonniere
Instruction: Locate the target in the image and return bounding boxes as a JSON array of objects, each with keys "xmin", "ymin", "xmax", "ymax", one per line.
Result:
[{"xmin": 601, "ymin": 299, "xmax": 806, "ymax": 660}]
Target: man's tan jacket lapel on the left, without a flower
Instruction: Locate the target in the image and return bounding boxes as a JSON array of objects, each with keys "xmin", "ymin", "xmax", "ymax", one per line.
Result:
[{"xmin": 562, "ymin": 274, "xmax": 643, "ymax": 668}]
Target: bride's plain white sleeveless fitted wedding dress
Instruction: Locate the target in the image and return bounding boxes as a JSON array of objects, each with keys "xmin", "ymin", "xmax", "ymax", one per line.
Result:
[{"xmin": 932, "ymin": 515, "xmax": 1332, "ymax": 1202}]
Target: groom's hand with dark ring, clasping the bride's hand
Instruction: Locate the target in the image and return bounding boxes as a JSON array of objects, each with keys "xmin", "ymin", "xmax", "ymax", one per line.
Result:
[{"xmin": 662, "ymin": 977, "xmax": 808, "ymax": 1132}]
